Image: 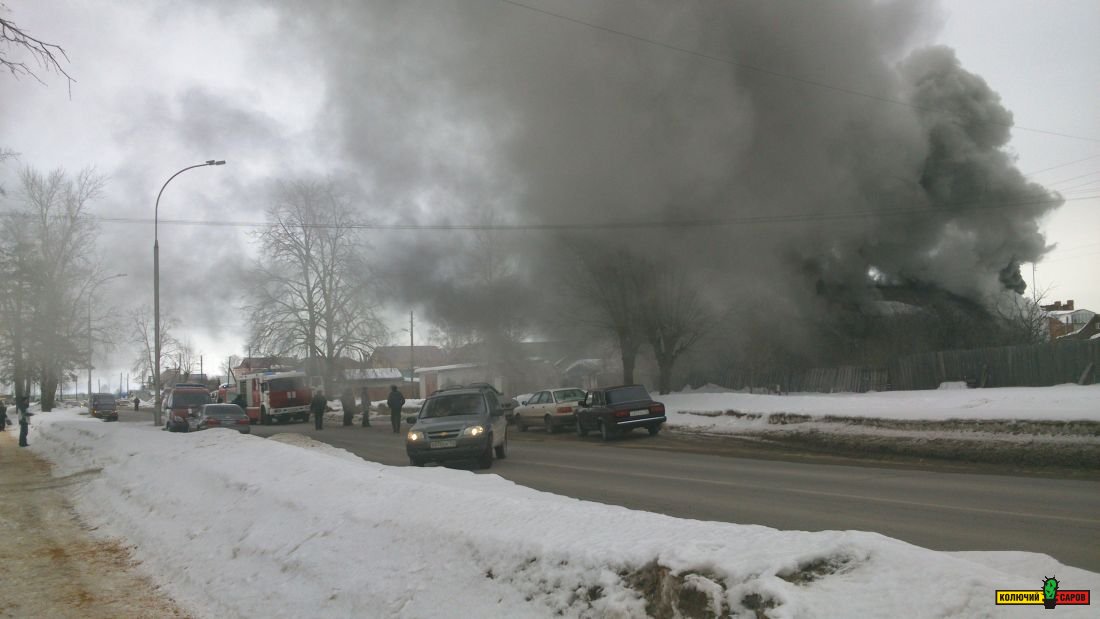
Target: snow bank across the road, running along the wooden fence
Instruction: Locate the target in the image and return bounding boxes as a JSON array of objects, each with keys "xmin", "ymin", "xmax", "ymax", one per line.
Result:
[{"xmin": 656, "ymin": 385, "xmax": 1100, "ymax": 433}]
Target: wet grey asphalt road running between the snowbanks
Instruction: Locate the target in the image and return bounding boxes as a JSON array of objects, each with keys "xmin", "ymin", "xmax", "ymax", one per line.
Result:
[{"xmin": 123, "ymin": 413, "xmax": 1100, "ymax": 572}]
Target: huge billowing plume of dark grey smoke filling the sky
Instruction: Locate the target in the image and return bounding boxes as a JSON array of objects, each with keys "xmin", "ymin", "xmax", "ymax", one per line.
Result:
[{"xmin": 264, "ymin": 0, "xmax": 1059, "ymax": 354}]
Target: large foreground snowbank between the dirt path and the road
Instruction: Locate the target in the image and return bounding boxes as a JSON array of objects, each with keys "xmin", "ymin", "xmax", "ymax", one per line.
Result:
[{"xmin": 17, "ymin": 411, "xmax": 1100, "ymax": 618}]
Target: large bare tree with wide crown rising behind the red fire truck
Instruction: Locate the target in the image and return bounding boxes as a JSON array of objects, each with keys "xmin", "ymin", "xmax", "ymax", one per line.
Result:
[{"xmin": 245, "ymin": 180, "xmax": 386, "ymax": 387}]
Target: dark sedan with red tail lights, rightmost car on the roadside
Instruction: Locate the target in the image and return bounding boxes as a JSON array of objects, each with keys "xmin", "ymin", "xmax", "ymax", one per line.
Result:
[{"xmin": 576, "ymin": 385, "xmax": 667, "ymax": 441}]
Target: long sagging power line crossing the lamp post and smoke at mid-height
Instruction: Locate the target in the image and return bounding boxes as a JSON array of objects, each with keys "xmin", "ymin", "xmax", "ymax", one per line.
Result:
[{"xmin": 0, "ymin": 195, "xmax": 1086, "ymax": 232}]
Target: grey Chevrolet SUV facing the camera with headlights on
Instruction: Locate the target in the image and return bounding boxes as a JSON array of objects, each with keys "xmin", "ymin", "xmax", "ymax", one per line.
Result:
[{"xmin": 405, "ymin": 385, "xmax": 513, "ymax": 468}]
